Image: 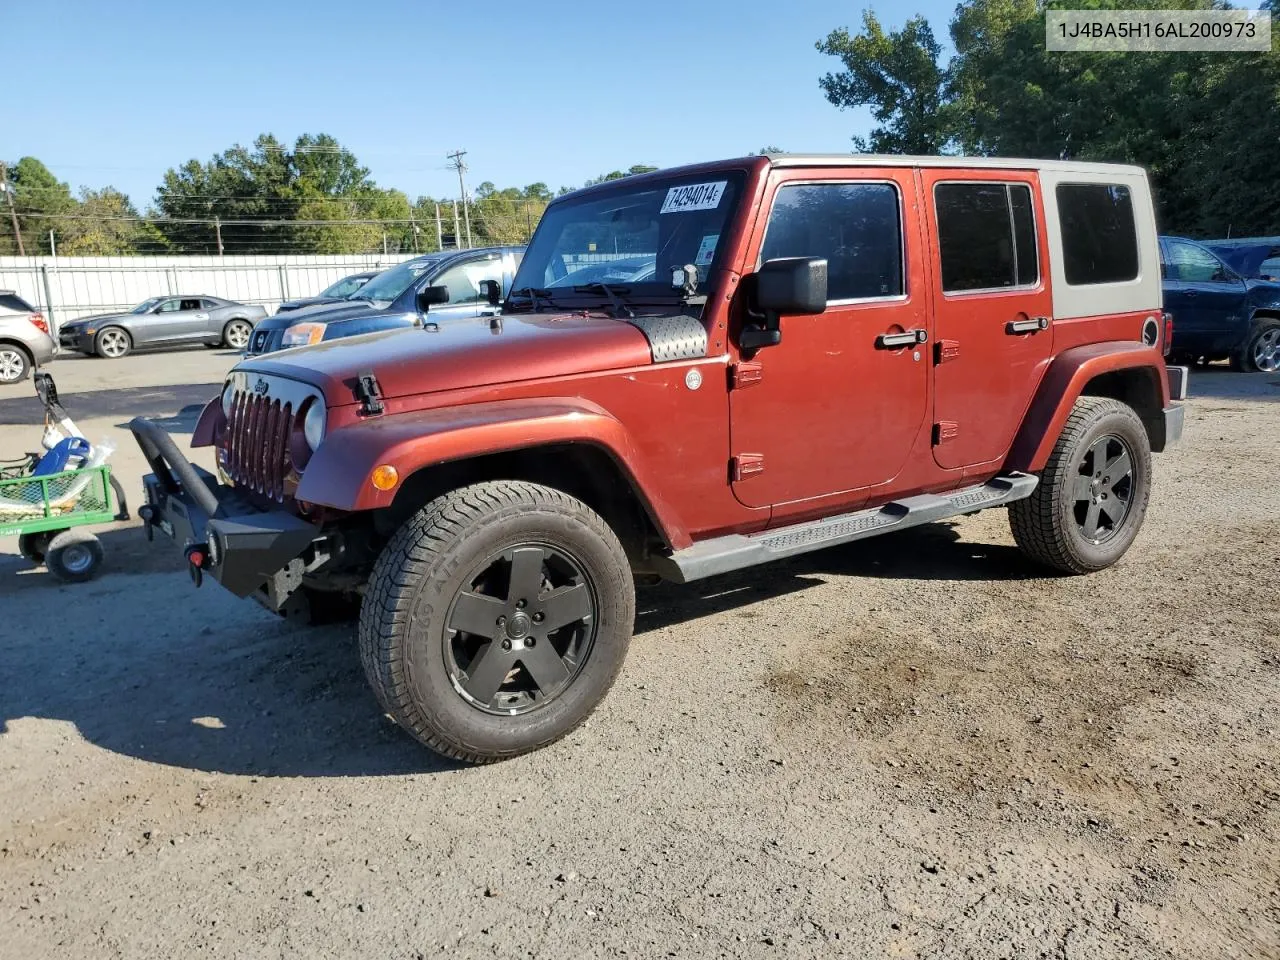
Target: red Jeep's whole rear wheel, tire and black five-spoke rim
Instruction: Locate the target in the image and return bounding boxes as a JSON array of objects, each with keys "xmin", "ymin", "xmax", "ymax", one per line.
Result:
[{"xmin": 1009, "ymin": 397, "xmax": 1151, "ymax": 573}]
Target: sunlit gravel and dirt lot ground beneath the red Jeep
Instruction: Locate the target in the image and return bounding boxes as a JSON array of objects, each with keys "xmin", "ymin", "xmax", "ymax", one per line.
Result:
[{"xmin": 0, "ymin": 351, "xmax": 1280, "ymax": 960}]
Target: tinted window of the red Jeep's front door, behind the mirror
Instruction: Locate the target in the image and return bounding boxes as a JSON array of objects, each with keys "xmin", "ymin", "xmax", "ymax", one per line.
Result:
[{"xmin": 760, "ymin": 183, "xmax": 904, "ymax": 301}]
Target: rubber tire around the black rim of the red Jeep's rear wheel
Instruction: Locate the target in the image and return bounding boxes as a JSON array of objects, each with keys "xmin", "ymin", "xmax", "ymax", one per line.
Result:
[{"xmin": 1009, "ymin": 397, "xmax": 1151, "ymax": 573}]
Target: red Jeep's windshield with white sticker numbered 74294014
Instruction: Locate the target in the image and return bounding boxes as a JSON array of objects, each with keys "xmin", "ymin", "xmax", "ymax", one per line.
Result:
[{"xmin": 512, "ymin": 172, "xmax": 742, "ymax": 300}]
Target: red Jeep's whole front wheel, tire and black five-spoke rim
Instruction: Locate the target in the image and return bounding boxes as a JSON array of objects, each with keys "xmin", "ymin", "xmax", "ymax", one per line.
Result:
[{"xmin": 358, "ymin": 480, "xmax": 635, "ymax": 763}]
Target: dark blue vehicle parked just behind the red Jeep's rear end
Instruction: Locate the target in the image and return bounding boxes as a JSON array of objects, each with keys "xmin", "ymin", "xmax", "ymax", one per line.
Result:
[{"xmin": 1160, "ymin": 237, "xmax": 1280, "ymax": 372}]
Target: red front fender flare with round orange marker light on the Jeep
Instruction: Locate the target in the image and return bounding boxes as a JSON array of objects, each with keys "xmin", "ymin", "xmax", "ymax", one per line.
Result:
[{"xmin": 297, "ymin": 397, "xmax": 691, "ymax": 549}]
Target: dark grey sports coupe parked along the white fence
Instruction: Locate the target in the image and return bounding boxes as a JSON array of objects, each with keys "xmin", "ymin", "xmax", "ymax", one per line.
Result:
[{"xmin": 58, "ymin": 294, "xmax": 266, "ymax": 360}]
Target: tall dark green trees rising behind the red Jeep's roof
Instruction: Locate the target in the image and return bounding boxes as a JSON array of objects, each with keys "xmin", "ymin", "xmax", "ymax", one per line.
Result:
[{"xmin": 818, "ymin": 0, "xmax": 1280, "ymax": 237}]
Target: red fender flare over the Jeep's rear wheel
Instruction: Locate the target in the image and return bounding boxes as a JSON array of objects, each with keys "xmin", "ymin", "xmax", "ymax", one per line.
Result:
[{"xmin": 1005, "ymin": 340, "xmax": 1169, "ymax": 472}]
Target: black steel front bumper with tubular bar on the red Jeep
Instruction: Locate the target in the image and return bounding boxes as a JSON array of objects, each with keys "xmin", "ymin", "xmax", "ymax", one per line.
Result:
[{"xmin": 129, "ymin": 417, "xmax": 321, "ymax": 609}]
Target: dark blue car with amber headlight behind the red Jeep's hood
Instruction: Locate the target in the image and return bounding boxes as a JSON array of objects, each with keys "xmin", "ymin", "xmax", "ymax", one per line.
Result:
[{"xmin": 250, "ymin": 247, "xmax": 525, "ymax": 353}]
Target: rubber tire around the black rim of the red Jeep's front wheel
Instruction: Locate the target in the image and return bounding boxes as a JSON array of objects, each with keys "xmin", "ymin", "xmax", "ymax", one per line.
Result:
[{"xmin": 358, "ymin": 480, "xmax": 635, "ymax": 763}]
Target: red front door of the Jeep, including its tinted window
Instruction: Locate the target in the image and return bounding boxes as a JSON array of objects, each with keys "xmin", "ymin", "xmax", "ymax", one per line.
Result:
[{"xmin": 730, "ymin": 170, "xmax": 929, "ymax": 507}]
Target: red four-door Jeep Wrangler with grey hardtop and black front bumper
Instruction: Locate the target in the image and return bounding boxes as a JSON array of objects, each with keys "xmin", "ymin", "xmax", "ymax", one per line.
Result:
[{"xmin": 132, "ymin": 155, "xmax": 1187, "ymax": 762}]
